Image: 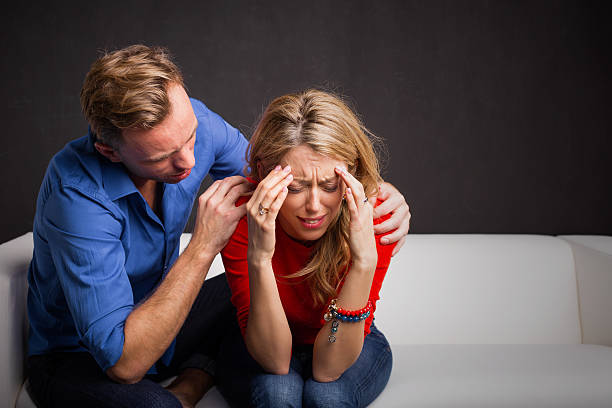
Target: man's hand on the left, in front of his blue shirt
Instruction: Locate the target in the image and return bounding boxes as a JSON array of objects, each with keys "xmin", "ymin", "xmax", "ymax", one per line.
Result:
[{"xmin": 189, "ymin": 176, "xmax": 252, "ymax": 257}]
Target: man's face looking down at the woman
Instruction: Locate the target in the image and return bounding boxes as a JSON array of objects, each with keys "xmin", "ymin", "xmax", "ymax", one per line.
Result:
[{"xmin": 114, "ymin": 84, "xmax": 198, "ymax": 184}]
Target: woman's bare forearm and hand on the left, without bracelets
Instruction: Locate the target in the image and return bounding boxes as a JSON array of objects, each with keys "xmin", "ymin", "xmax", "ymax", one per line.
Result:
[{"xmin": 244, "ymin": 166, "xmax": 293, "ymax": 374}]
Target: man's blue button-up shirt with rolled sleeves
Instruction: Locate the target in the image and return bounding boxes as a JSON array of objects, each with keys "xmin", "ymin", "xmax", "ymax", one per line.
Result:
[{"xmin": 28, "ymin": 99, "xmax": 247, "ymax": 372}]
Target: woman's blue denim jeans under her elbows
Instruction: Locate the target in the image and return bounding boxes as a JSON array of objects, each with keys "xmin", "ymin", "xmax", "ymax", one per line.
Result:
[{"xmin": 217, "ymin": 324, "xmax": 393, "ymax": 408}]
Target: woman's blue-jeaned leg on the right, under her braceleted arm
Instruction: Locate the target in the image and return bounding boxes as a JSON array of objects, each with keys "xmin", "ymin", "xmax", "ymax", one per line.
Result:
[{"xmin": 303, "ymin": 324, "xmax": 393, "ymax": 407}]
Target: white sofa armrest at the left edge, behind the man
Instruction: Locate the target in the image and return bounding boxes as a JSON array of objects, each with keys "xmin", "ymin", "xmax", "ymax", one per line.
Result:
[{"xmin": 0, "ymin": 232, "xmax": 33, "ymax": 407}]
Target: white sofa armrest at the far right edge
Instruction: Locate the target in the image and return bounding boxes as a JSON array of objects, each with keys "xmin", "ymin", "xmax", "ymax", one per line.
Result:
[{"xmin": 559, "ymin": 235, "xmax": 612, "ymax": 346}]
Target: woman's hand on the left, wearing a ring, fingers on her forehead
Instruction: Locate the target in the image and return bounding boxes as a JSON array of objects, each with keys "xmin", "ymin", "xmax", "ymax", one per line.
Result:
[{"xmin": 246, "ymin": 166, "xmax": 293, "ymax": 262}]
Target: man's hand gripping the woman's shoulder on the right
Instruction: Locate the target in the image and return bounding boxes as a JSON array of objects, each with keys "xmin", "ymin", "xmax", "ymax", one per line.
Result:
[{"xmin": 374, "ymin": 182, "xmax": 411, "ymax": 255}]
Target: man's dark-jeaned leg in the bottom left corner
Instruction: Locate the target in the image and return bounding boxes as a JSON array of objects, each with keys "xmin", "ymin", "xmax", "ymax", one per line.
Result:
[{"xmin": 28, "ymin": 353, "xmax": 181, "ymax": 408}]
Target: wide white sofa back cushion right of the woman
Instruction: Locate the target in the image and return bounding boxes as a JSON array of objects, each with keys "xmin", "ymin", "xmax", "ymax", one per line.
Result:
[{"xmin": 375, "ymin": 234, "xmax": 581, "ymax": 344}]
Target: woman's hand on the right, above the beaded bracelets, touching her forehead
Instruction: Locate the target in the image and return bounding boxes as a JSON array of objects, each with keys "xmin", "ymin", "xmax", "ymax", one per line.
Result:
[{"xmin": 336, "ymin": 167, "xmax": 378, "ymax": 273}]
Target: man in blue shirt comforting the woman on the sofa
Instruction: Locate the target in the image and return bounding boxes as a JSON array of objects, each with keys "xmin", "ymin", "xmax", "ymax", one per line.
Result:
[{"xmin": 28, "ymin": 45, "xmax": 410, "ymax": 407}]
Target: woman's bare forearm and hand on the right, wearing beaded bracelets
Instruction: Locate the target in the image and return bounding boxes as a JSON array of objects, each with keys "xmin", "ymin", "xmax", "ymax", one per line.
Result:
[{"xmin": 312, "ymin": 168, "xmax": 378, "ymax": 382}]
